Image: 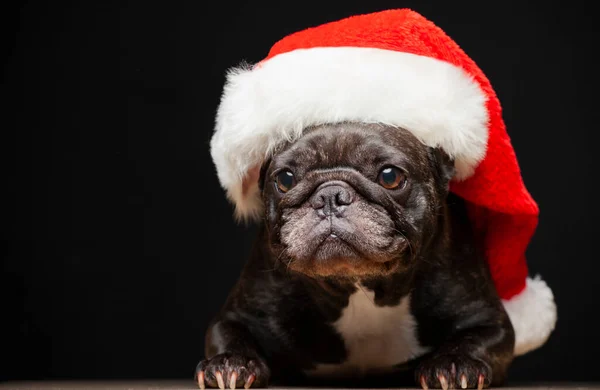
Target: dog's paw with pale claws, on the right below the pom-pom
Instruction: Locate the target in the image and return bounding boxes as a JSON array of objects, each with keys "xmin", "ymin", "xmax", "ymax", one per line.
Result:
[{"xmin": 415, "ymin": 354, "xmax": 492, "ymax": 390}]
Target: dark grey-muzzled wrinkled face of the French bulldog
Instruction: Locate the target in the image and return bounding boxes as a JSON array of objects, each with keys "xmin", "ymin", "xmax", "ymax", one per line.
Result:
[{"xmin": 260, "ymin": 123, "xmax": 454, "ymax": 278}]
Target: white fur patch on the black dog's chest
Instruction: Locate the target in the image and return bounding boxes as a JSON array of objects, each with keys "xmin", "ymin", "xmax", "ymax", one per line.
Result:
[{"xmin": 307, "ymin": 286, "xmax": 428, "ymax": 377}]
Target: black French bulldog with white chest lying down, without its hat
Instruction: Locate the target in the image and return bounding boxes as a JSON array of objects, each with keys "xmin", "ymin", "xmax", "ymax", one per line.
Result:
[{"xmin": 195, "ymin": 123, "xmax": 515, "ymax": 390}]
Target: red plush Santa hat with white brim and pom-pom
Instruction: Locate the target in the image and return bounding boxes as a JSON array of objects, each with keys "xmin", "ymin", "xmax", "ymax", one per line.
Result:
[{"xmin": 211, "ymin": 9, "xmax": 556, "ymax": 355}]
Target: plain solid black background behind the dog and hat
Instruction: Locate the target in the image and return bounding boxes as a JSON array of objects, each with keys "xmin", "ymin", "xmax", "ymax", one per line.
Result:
[{"xmin": 0, "ymin": 0, "xmax": 600, "ymax": 381}]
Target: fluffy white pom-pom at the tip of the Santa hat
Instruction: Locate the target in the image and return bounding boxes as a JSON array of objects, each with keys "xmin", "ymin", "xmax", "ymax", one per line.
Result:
[{"xmin": 503, "ymin": 276, "xmax": 557, "ymax": 356}]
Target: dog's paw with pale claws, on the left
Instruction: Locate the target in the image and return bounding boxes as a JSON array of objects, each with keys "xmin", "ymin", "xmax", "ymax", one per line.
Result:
[{"xmin": 196, "ymin": 353, "xmax": 270, "ymax": 389}]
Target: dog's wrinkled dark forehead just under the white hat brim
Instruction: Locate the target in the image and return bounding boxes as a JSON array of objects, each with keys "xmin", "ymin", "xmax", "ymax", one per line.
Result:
[{"xmin": 273, "ymin": 123, "xmax": 428, "ymax": 176}]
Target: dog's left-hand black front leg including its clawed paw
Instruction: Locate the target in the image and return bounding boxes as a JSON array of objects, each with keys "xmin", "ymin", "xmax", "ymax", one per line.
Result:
[{"xmin": 196, "ymin": 319, "xmax": 270, "ymax": 389}]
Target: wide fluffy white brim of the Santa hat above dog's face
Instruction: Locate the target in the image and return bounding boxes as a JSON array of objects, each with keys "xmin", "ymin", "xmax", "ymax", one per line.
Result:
[{"xmin": 211, "ymin": 47, "xmax": 488, "ymax": 218}]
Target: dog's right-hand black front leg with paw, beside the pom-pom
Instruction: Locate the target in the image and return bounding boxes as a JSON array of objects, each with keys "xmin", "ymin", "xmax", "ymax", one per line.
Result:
[{"xmin": 415, "ymin": 319, "xmax": 514, "ymax": 390}]
